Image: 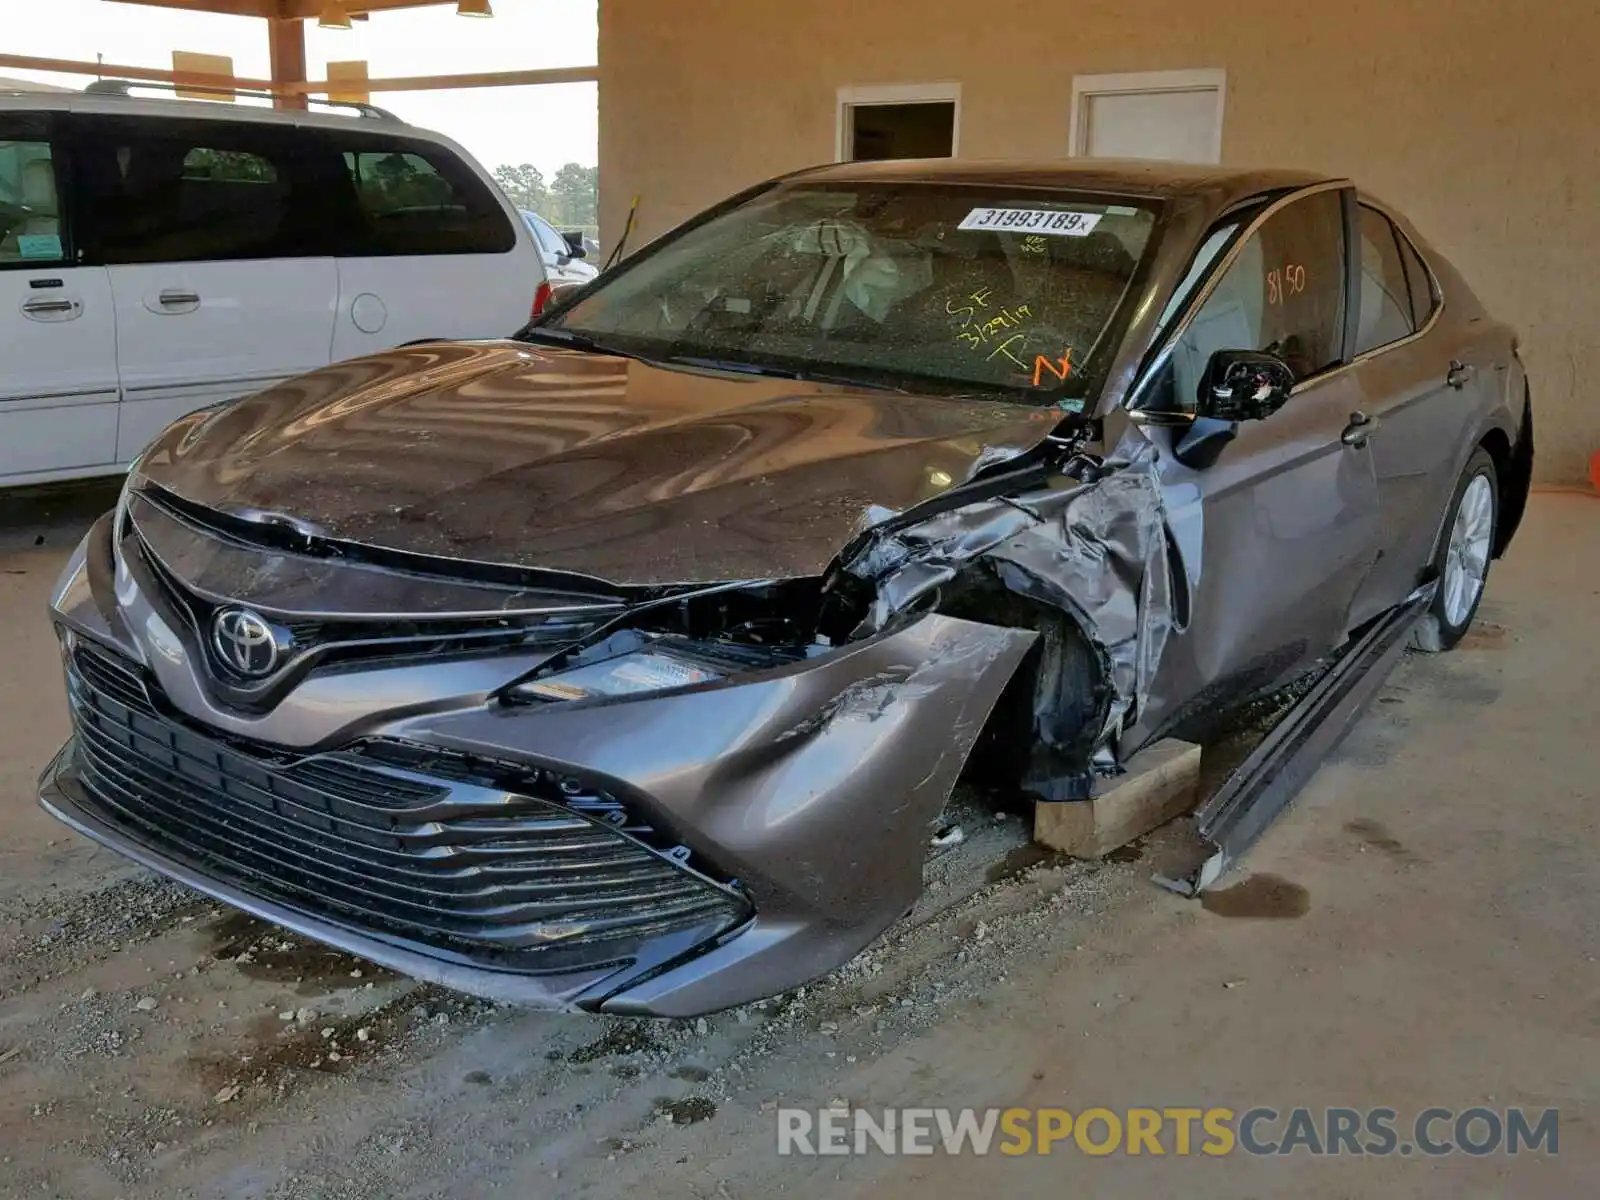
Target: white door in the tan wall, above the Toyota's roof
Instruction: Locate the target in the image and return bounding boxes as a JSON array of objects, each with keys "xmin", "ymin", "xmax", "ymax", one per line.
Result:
[{"xmin": 1070, "ymin": 70, "xmax": 1226, "ymax": 163}]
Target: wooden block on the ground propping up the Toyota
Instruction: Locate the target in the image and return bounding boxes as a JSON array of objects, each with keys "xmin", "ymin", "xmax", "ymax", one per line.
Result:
[{"xmin": 1034, "ymin": 738, "xmax": 1200, "ymax": 858}]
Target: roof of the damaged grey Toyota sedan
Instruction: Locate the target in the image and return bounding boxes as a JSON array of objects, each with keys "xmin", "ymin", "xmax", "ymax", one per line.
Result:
[{"xmin": 800, "ymin": 158, "xmax": 1338, "ymax": 198}]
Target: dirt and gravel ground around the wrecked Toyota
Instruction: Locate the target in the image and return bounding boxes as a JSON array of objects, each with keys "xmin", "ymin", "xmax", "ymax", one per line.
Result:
[{"xmin": 0, "ymin": 496, "xmax": 1600, "ymax": 1200}]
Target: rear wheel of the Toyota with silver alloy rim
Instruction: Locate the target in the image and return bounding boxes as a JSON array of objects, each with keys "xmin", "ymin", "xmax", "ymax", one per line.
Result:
[{"xmin": 1411, "ymin": 446, "xmax": 1499, "ymax": 653}]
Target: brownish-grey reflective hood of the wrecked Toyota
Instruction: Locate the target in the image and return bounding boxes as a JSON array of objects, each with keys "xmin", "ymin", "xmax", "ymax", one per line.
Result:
[{"xmin": 139, "ymin": 341, "xmax": 1059, "ymax": 584}]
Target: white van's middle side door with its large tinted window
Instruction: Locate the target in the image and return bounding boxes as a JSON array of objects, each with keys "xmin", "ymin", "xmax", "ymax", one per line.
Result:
[{"xmin": 72, "ymin": 114, "xmax": 338, "ymax": 462}]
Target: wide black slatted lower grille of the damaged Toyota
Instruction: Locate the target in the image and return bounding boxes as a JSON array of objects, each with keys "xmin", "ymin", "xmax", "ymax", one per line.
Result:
[{"xmin": 67, "ymin": 642, "xmax": 749, "ymax": 973}]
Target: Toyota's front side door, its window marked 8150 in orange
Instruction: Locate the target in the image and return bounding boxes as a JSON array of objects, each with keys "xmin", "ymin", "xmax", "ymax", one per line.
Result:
[{"xmin": 1133, "ymin": 187, "xmax": 1381, "ymax": 742}]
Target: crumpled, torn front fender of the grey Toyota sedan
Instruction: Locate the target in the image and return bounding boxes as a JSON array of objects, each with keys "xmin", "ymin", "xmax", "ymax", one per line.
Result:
[{"xmin": 845, "ymin": 440, "xmax": 1173, "ymax": 800}]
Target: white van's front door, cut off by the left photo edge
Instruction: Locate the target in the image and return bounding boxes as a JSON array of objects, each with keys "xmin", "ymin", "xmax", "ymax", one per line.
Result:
[{"xmin": 0, "ymin": 112, "xmax": 117, "ymax": 486}]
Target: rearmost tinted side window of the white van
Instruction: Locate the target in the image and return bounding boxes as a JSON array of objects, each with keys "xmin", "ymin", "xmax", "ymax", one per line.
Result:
[{"xmin": 338, "ymin": 142, "xmax": 517, "ymax": 258}]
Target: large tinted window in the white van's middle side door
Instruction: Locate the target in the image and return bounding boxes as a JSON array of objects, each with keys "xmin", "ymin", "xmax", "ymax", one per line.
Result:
[{"xmin": 74, "ymin": 117, "xmax": 326, "ymax": 266}]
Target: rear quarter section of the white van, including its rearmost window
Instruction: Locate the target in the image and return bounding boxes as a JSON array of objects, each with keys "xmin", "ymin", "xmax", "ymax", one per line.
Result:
[{"xmin": 323, "ymin": 126, "xmax": 544, "ymax": 360}]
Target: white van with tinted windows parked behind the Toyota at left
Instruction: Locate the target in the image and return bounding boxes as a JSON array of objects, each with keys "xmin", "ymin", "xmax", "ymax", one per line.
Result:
[{"xmin": 0, "ymin": 85, "xmax": 549, "ymax": 488}]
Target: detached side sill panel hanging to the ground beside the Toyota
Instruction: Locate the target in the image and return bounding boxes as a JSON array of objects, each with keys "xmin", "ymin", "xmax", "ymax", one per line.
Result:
[{"xmin": 1158, "ymin": 584, "xmax": 1435, "ymax": 894}]
